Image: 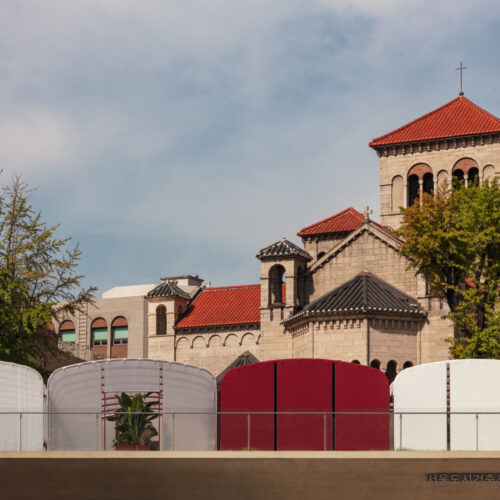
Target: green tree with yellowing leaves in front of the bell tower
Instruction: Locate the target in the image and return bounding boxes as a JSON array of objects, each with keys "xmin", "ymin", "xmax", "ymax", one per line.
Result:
[{"xmin": 399, "ymin": 182, "xmax": 500, "ymax": 358}]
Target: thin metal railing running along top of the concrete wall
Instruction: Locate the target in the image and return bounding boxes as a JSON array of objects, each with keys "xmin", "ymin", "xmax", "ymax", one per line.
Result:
[{"xmin": 0, "ymin": 410, "xmax": 500, "ymax": 451}]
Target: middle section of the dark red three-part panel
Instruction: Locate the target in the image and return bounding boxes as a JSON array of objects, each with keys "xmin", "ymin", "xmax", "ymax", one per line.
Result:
[{"xmin": 278, "ymin": 359, "xmax": 332, "ymax": 450}]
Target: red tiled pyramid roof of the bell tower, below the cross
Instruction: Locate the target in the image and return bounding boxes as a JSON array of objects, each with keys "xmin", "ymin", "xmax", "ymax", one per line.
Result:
[{"xmin": 369, "ymin": 96, "xmax": 500, "ymax": 147}]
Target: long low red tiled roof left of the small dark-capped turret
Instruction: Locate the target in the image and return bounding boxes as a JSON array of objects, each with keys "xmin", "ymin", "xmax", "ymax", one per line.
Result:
[{"xmin": 176, "ymin": 285, "xmax": 260, "ymax": 328}]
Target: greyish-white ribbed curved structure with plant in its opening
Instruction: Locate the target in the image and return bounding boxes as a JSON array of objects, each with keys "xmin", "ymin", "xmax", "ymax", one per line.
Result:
[{"xmin": 48, "ymin": 359, "xmax": 217, "ymax": 450}]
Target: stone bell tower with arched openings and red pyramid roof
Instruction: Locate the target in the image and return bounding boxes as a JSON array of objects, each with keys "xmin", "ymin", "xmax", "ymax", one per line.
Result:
[{"xmin": 369, "ymin": 93, "xmax": 500, "ymax": 229}]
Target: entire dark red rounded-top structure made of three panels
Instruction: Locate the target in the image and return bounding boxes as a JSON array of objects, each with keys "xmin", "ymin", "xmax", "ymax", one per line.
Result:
[{"xmin": 219, "ymin": 359, "xmax": 389, "ymax": 450}]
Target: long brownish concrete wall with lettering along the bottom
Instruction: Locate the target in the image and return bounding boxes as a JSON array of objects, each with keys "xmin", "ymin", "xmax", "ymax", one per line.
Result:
[{"xmin": 0, "ymin": 451, "xmax": 500, "ymax": 500}]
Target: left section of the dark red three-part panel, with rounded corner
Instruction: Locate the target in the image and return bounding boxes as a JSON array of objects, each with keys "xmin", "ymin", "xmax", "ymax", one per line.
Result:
[{"xmin": 219, "ymin": 363, "xmax": 274, "ymax": 450}]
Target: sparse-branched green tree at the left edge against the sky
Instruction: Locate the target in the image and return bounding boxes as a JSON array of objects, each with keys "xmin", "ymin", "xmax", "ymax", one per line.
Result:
[{"xmin": 0, "ymin": 177, "xmax": 95, "ymax": 372}]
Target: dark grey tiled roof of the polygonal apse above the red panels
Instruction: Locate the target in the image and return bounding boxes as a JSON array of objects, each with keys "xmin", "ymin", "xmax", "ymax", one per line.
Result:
[{"xmin": 285, "ymin": 271, "xmax": 425, "ymax": 323}]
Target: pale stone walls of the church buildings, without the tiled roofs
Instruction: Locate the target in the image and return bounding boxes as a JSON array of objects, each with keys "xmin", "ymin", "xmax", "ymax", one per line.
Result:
[{"xmin": 56, "ymin": 95, "xmax": 500, "ymax": 375}]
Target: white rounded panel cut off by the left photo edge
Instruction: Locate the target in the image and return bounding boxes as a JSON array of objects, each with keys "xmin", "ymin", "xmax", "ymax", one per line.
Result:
[{"xmin": 0, "ymin": 361, "xmax": 44, "ymax": 451}]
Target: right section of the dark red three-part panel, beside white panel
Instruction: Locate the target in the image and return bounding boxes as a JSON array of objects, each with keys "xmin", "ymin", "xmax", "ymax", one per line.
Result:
[{"xmin": 335, "ymin": 362, "xmax": 389, "ymax": 450}]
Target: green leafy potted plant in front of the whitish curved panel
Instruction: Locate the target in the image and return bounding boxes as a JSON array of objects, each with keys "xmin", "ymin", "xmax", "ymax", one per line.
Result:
[{"xmin": 107, "ymin": 392, "xmax": 158, "ymax": 450}]
